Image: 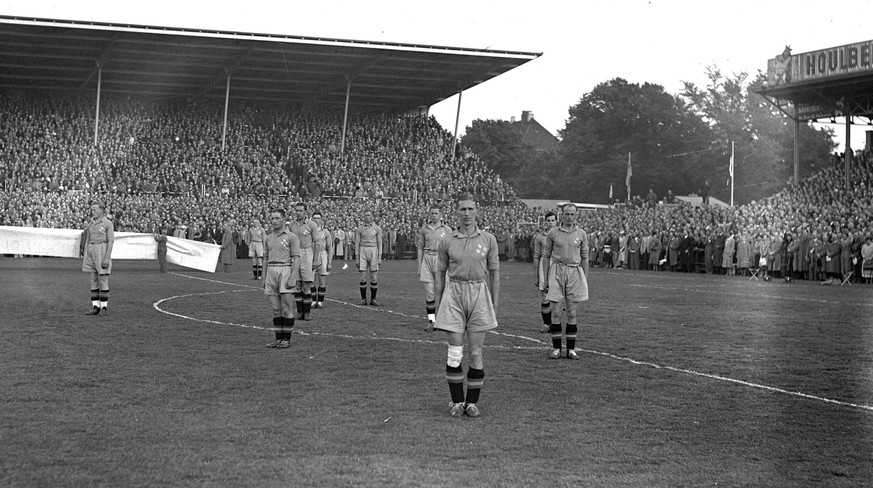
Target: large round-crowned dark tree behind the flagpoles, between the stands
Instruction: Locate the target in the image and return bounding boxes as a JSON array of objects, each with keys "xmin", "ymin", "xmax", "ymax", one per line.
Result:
[{"xmin": 561, "ymin": 78, "xmax": 711, "ymax": 202}]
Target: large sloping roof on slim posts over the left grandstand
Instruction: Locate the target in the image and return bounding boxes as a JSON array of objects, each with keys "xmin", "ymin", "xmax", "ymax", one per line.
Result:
[{"xmin": 0, "ymin": 16, "xmax": 542, "ymax": 111}]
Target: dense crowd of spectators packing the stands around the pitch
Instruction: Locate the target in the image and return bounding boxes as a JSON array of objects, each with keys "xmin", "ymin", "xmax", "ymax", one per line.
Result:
[{"xmin": 0, "ymin": 96, "xmax": 873, "ymax": 283}]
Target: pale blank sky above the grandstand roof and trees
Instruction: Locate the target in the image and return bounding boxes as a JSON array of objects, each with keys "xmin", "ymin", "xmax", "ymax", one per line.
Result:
[{"xmin": 0, "ymin": 0, "xmax": 873, "ymax": 149}]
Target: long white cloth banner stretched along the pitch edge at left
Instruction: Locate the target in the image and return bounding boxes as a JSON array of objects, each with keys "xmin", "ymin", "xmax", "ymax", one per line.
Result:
[{"xmin": 0, "ymin": 226, "xmax": 221, "ymax": 273}]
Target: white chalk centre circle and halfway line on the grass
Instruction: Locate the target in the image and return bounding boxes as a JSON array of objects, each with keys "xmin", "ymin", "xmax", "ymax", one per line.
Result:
[{"xmin": 153, "ymin": 273, "xmax": 873, "ymax": 412}]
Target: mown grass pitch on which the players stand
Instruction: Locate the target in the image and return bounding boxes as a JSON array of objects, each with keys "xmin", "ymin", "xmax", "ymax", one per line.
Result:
[{"xmin": 0, "ymin": 258, "xmax": 873, "ymax": 487}]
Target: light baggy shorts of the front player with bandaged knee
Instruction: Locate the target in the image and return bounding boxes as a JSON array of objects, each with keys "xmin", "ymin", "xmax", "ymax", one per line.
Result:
[{"xmin": 434, "ymin": 280, "xmax": 497, "ymax": 332}]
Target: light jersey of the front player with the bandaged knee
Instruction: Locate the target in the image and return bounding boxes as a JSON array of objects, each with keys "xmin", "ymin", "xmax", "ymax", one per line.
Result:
[{"xmin": 437, "ymin": 228, "xmax": 500, "ymax": 281}]
